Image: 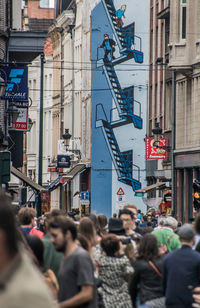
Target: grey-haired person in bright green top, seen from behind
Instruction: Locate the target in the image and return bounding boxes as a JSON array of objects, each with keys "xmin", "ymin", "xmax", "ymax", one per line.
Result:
[{"xmin": 152, "ymin": 216, "xmax": 181, "ymax": 254}]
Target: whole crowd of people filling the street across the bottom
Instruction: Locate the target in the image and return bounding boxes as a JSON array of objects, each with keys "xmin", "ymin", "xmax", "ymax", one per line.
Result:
[{"xmin": 0, "ymin": 194, "xmax": 200, "ymax": 308}]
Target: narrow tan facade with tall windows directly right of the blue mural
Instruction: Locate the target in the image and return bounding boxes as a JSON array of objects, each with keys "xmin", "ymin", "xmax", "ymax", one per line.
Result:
[{"xmin": 146, "ymin": 0, "xmax": 172, "ymax": 205}]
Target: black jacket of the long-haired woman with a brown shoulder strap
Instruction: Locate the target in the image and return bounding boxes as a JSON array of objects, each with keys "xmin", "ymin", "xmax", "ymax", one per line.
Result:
[{"xmin": 129, "ymin": 258, "xmax": 163, "ymax": 307}]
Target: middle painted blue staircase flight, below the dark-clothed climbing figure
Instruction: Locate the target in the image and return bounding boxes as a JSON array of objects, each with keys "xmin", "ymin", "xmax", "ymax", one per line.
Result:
[{"xmin": 98, "ymin": 60, "xmax": 143, "ymax": 129}]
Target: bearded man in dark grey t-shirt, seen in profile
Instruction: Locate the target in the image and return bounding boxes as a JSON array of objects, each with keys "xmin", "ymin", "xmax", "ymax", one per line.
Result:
[{"xmin": 49, "ymin": 216, "xmax": 96, "ymax": 308}]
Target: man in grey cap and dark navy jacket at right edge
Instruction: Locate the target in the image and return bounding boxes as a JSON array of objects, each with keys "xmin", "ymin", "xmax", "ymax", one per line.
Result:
[{"xmin": 162, "ymin": 224, "xmax": 200, "ymax": 308}]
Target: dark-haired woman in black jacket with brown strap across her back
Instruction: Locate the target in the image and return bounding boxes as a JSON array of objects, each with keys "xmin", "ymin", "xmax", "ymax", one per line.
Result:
[{"xmin": 129, "ymin": 234, "xmax": 165, "ymax": 308}]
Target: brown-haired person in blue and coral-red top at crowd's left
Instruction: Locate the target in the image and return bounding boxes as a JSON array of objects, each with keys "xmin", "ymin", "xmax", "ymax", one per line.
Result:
[{"xmin": 18, "ymin": 207, "xmax": 44, "ymax": 239}]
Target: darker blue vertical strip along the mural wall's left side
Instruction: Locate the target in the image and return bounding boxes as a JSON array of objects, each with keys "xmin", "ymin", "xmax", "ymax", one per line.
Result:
[{"xmin": 91, "ymin": 2, "xmax": 112, "ymax": 217}]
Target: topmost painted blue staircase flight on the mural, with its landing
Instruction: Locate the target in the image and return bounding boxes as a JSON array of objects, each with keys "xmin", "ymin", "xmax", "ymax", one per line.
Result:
[{"xmin": 102, "ymin": 0, "xmax": 144, "ymax": 65}]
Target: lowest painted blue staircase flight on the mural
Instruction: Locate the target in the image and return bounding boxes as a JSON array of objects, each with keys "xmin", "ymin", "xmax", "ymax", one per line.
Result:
[{"xmin": 96, "ymin": 112, "xmax": 141, "ymax": 191}]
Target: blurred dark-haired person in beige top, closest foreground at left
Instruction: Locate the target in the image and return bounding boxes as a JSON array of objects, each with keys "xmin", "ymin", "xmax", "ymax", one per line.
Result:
[{"xmin": 0, "ymin": 194, "xmax": 57, "ymax": 308}]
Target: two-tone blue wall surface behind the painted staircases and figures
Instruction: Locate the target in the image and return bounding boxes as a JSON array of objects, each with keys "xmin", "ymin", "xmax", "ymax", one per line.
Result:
[{"xmin": 91, "ymin": 0, "xmax": 149, "ymax": 217}]
